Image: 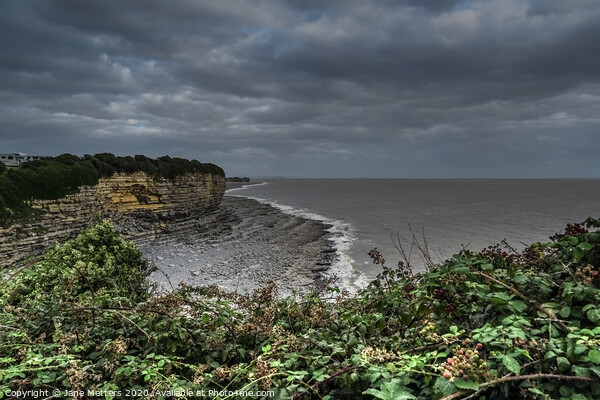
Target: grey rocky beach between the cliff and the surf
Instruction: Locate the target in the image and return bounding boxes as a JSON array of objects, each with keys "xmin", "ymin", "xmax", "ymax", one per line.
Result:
[{"xmin": 140, "ymin": 195, "xmax": 336, "ymax": 296}]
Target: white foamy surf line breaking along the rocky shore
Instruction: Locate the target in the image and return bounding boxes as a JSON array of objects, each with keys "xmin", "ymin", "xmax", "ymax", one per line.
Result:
[{"xmin": 227, "ymin": 191, "xmax": 371, "ymax": 294}]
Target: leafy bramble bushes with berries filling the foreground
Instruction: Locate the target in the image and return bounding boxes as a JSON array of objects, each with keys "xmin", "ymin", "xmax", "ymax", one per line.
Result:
[{"xmin": 0, "ymin": 219, "xmax": 600, "ymax": 400}]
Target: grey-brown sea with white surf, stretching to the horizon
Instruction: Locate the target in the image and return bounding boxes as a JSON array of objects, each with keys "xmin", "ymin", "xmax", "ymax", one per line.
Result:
[{"xmin": 226, "ymin": 179, "xmax": 600, "ymax": 287}]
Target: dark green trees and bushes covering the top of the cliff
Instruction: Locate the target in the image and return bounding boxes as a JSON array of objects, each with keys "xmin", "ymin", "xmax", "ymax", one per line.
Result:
[{"xmin": 0, "ymin": 153, "xmax": 225, "ymax": 226}]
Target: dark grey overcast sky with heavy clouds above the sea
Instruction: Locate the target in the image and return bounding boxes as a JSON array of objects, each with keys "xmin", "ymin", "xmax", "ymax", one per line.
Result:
[{"xmin": 0, "ymin": 0, "xmax": 600, "ymax": 177}]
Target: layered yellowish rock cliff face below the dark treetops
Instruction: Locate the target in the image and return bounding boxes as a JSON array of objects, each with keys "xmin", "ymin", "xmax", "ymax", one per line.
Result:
[{"xmin": 0, "ymin": 172, "xmax": 225, "ymax": 267}]
